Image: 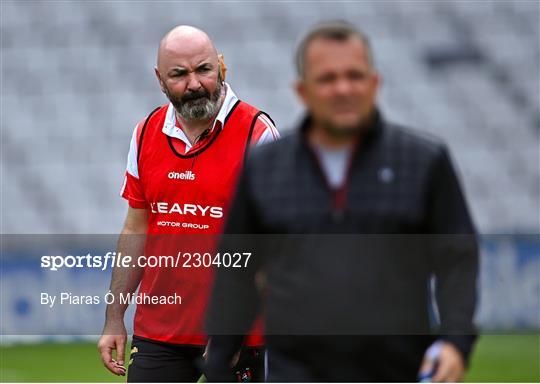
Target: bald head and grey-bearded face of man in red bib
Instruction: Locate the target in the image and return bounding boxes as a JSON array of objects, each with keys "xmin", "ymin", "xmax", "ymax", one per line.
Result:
[{"xmin": 155, "ymin": 26, "xmax": 223, "ymax": 121}]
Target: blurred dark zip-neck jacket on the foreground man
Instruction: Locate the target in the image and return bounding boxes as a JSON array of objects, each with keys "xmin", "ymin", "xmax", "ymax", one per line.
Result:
[{"xmin": 208, "ymin": 113, "xmax": 478, "ymax": 380}]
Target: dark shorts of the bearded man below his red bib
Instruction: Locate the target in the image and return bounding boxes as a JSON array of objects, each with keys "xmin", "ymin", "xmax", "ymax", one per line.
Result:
[{"xmin": 127, "ymin": 336, "xmax": 264, "ymax": 383}]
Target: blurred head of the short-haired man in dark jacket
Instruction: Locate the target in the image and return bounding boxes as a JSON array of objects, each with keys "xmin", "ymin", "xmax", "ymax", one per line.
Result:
[{"xmin": 296, "ymin": 22, "xmax": 380, "ymax": 138}]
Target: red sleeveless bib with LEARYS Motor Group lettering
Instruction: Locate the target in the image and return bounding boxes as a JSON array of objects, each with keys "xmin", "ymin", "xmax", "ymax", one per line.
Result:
[{"xmin": 134, "ymin": 101, "xmax": 262, "ymax": 345}]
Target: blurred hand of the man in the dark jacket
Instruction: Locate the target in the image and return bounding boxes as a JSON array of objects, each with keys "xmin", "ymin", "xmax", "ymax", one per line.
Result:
[{"xmin": 419, "ymin": 341, "xmax": 465, "ymax": 383}]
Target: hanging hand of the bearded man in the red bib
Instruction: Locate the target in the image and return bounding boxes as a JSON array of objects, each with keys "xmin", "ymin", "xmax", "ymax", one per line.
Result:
[{"xmin": 97, "ymin": 321, "xmax": 127, "ymax": 376}]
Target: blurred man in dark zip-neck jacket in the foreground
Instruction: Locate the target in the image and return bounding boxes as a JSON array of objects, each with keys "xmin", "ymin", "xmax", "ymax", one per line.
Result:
[{"xmin": 207, "ymin": 22, "xmax": 477, "ymax": 382}]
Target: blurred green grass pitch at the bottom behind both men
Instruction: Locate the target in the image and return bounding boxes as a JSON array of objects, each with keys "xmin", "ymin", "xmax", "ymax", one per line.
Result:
[{"xmin": 0, "ymin": 334, "xmax": 540, "ymax": 383}]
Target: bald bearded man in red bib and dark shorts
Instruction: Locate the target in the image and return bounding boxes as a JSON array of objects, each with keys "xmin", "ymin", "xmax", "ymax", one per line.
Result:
[{"xmin": 98, "ymin": 26, "xmax": 279, "ymax": 382}]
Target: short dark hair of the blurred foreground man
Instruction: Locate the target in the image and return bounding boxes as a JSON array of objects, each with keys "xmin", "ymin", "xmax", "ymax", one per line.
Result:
[{"xmin": 296, "ymin": 20, "xmax": 374, "ymax": 77}]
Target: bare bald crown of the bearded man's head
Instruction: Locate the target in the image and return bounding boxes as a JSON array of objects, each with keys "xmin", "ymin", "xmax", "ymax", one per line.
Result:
[{"xmin": 157, "ymin": 25, "xmax": 217, "ymax": 69}]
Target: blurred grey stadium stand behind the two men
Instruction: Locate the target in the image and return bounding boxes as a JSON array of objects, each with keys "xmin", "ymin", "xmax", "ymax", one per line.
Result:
[{"xmin": 1, "ymin": 0, "xmax": 540, "ymax": 233}]
